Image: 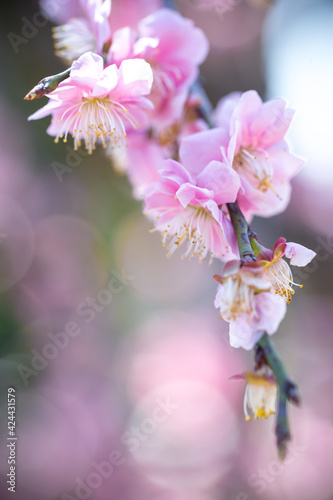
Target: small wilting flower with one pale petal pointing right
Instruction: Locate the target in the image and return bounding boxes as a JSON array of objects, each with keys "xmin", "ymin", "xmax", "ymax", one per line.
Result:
[{"xmin": 256, "ymin": 237, "xmax": 316, "ymax": 303}]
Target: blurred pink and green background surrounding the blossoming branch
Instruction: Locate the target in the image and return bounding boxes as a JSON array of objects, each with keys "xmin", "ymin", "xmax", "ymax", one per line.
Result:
[{"xmin": 0, "ymin": 0, "xmax": 333, "ymax": 500}]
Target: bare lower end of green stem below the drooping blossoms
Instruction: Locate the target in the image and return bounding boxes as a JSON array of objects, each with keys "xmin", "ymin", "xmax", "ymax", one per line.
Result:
[{"xmin": 257, "ymin": 333, "xmax": 301, "ymax": 459}]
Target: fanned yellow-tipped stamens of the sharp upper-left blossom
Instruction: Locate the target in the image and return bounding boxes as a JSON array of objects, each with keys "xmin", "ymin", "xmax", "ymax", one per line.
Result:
[{"xmin": 55, "ymin": 97, "xmax": 137, "ymax": 154}]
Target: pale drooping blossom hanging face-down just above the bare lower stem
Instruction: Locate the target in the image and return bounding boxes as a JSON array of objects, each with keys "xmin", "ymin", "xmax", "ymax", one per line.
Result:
[{"xmin": 214, "ymin": 261, "xmax": 286, "ymax": 350}]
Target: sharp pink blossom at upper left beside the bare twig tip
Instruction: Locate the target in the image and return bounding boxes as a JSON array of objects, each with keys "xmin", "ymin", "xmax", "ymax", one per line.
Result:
[{"xmin": 29, "ymin": 52, "xmax": 153, "ymax": 153}]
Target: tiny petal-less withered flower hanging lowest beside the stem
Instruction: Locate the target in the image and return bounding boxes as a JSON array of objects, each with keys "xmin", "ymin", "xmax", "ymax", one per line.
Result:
[{"xmin": 231, "ymin": 368, "xmax": 277, "ymax": 420}]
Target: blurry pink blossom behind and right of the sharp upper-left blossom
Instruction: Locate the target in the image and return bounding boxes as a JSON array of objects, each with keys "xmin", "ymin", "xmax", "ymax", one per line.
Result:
[{"xmin": 108, "ymin": 9, "xmax": 208, "ymax": 129}]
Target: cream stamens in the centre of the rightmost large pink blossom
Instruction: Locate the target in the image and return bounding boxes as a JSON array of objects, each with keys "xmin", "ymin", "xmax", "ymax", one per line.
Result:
[{"xmin": 233, "ymin": 148, "xmax": 280, "ymax": 198}]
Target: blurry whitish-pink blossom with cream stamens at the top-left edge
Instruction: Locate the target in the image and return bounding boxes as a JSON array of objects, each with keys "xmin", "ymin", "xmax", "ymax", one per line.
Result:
[{"xmin": 53, "ymin": 0, "xmax": 111, "ymax": 61}]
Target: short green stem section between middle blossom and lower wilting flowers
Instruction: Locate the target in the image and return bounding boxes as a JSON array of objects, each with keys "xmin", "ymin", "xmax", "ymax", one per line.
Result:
[{"xmin": 227, "ymin": 202, "xmax": 256, "ymax": 265}]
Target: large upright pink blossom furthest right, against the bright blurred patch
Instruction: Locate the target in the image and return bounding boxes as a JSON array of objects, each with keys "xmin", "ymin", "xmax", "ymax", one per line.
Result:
[{"xmin": 215, "ymin": 90, "xmax": 304, "ymax": 219}]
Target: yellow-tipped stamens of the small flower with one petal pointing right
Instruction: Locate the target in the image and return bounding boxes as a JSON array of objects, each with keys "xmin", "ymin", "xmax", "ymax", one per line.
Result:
[{"xmin": 264, "ymin": 259, "xmax": 303, "ymax": 304}]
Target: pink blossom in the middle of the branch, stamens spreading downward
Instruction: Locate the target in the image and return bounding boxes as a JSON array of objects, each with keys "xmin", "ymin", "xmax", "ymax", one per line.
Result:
[{"xmin": 144, "ymin": 156, "xmax": 239, "ymax": 260}]
